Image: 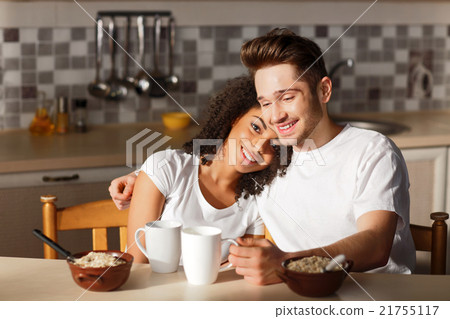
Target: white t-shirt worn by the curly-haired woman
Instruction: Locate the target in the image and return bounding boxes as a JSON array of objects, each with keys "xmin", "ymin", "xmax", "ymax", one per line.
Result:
[{"xmin": 141, "ymin": 149, "xmax": 264, "ymax": 260}]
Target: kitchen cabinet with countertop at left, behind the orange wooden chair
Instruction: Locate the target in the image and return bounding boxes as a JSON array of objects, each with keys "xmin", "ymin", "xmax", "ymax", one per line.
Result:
[{"xmin": 0, "ymin": 123, "xmax": 199, "ymax": 258}]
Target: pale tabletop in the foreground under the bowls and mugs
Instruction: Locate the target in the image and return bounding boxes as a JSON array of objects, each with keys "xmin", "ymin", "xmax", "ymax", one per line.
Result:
[{"xmin": 0, "ymin": 257, "xmax": 450, "ymax": 301}]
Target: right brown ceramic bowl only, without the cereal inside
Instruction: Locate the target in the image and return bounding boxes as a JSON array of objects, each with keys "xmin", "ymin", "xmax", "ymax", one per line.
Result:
[{"xmin": 277, "ymin": 257, "xmax": 353, "ymax": 297}]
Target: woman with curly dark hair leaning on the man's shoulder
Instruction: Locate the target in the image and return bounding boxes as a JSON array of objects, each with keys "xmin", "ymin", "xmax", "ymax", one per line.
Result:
[{"xmin": 127, "ymin": 77, "xmax": 290, "ymax": 262}]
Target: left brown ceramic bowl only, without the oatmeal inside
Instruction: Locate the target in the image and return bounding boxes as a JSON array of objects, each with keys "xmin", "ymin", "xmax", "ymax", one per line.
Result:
[{"xmin": 67, "ymin": 250, "xmax": 134, "ymax": 291}]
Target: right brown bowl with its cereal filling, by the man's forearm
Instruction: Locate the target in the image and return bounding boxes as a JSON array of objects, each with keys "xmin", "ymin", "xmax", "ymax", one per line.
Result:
[{"xmin": 277, "ymin": 256, "xmax": 353, "ymax": 297}]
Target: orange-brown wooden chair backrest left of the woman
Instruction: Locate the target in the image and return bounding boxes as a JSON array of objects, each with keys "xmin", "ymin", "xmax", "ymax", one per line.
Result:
[{"xmin": 41, "ymin": 195, "xmax": 128, "ymax": 259}]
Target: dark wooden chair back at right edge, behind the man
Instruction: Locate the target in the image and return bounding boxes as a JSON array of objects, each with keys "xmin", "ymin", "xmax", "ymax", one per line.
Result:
[{"xmin": 411, "ymin": 212, "xmax": 448, "ymax": 275}]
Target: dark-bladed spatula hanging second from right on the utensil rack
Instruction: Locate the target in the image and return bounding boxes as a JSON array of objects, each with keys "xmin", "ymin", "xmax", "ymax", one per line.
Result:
[{"xmin": 149, "ymin": 15, "xmax": 167, "ymax": 97}]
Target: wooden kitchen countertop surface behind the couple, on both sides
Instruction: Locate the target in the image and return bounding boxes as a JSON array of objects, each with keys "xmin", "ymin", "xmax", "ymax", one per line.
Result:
[{"xmin": 0, "ymin": 110, "xmax": 450, "ymax": 173}]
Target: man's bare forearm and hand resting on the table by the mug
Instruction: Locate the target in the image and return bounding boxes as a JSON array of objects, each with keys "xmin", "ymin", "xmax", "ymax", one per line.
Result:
[{"xmin": 229, "ymin": 211, "xmax": 398, "ymax": 285}]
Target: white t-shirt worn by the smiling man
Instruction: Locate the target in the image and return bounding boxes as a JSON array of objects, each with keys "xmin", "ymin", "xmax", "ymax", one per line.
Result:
[{"xmin": 257, "ymin": 125, "xmax": 415, "ymax": 273}]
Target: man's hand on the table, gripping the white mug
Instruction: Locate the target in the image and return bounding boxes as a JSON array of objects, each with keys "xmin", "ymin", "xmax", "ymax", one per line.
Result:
[{"xmin": 228, "ymin": 238, "xmax": 287, "ymax": 285}]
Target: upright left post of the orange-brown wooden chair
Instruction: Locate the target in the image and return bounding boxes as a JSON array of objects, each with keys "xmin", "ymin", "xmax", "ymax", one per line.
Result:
[{"xmin": 41, "ymin": 195, "xmax": 58, "ymax": 259}]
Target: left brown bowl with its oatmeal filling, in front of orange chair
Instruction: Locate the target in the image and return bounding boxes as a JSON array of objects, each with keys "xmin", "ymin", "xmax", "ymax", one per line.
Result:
[{"xmin": 67, "ymin": 250, "xmax": 133, "ymax": 291}]
